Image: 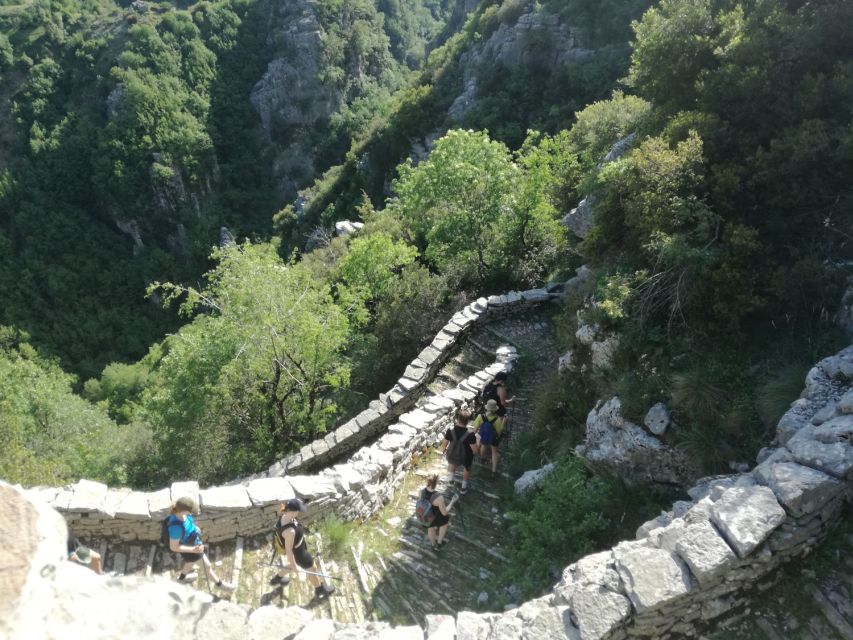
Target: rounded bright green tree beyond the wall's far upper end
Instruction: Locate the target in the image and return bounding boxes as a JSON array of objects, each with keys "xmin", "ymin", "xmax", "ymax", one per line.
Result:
[{"xmin": 388, "ymin": 130, "xmax": 562, "ymax": 290}]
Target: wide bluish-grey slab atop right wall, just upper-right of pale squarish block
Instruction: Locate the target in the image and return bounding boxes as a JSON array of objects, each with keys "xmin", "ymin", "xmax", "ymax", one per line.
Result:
[{"xmin": 753, "ymin": 462, "xmax": 844, "ymax": 518}]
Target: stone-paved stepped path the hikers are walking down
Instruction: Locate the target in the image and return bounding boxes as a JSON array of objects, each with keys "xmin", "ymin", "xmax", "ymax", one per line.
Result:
[{"xmin": 94, "ymin": 312, "xmax": 557, "ymax": 624}]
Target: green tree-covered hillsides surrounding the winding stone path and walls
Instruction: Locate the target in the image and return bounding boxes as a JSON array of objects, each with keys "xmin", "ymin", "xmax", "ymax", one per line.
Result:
[{"xmin": 0, "ymin": 0, "xmax": 853, "ymax": 556}]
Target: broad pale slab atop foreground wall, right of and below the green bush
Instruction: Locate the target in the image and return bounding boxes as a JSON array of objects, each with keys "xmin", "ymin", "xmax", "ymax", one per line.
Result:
[{"xmin": 613, "ymin": 543, "xmax": 693, "ymax": 613}]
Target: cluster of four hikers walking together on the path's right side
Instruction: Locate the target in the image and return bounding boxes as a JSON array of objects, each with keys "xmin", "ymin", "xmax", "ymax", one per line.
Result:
[{"xmin": 415, "ymin": 372, "xmax": 513, "ymax": 551}]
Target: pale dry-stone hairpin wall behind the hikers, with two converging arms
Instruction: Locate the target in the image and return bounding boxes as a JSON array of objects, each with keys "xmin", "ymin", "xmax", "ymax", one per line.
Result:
[{"xmin": 18, "ymin": 267, "xmax": 590, "ymax": 542}]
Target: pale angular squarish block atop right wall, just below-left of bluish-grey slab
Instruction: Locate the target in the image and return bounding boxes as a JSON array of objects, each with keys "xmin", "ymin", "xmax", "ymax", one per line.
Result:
[{"xmin": 710, "ymin": 486, "xmax": 787, "ymax": 558}]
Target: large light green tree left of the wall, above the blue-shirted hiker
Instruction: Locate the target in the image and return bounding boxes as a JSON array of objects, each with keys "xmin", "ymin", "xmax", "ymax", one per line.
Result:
[{"xmin": 140, "ymin": 244, "xmax": 349, "ymax": 480}]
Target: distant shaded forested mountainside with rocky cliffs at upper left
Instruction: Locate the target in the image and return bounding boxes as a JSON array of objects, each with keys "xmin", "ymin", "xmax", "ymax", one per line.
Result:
[{"xmin": 0, "ymin": 0, "xmax": 456, "ymax": 376}]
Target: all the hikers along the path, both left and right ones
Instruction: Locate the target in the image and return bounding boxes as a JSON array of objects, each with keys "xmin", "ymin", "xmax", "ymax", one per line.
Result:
[{"xmin": 68, "ymin": 373, "xmax": 512, "ymax": 599}]
